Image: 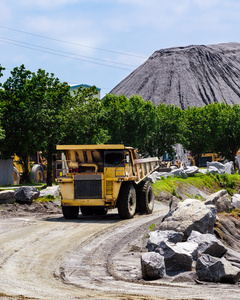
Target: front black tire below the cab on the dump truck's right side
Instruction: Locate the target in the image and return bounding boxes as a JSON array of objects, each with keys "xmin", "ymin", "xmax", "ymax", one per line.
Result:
[{"xmin": 118, "ymin": 183, "xmax": 137, "ymax": 219}]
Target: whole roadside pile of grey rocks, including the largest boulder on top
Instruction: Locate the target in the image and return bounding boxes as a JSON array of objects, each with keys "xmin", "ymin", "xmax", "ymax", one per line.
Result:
[{"xmin": 141, "ymin": 190, "xmax": 240, "ymax": 283}]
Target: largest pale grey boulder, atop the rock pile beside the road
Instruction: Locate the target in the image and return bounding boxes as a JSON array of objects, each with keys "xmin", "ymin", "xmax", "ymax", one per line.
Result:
[{"xmin": 159, "ymin": 199, "xmax": 217, "ymax": 240}]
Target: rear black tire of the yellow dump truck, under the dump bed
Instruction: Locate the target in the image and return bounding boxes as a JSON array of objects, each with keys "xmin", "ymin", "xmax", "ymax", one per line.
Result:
[{"xmin": 137, "ymin": 181, "xmax": 154, "ymax": 214}]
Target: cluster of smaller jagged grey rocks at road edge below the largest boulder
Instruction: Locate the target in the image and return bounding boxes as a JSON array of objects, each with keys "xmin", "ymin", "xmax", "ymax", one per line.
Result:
[{"xmin": 141, "ymin": 230, "xmax": 240, "ymax": 283}]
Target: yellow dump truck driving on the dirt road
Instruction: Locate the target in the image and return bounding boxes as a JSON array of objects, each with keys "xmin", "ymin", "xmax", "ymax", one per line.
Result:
[{"xmin": 56, "ymin": 144, "xmax": 159, "ymax": 219}]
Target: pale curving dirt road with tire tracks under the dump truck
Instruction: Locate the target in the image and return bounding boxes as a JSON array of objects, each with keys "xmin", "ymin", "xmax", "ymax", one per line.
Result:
[{"xmin": 0, "ymin": 205, "xmax": 240, "ymax": 300}]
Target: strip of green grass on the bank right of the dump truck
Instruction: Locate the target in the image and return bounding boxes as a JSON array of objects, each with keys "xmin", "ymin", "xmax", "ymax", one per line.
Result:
[{"xmin": 153, "ymin": 173, "xmax": 240, "ymax": 197}]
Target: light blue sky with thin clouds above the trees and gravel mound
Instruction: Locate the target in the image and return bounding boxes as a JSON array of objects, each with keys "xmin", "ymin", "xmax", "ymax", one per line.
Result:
[{"xmin": 0, "ymin": 0, "xmax": 240, "ymax": 97}]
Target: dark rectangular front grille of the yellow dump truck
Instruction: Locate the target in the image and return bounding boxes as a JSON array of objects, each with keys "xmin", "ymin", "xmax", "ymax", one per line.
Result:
[{"xmin": 74, "ymin": 175, "xmax": 102, "ymax": 199}]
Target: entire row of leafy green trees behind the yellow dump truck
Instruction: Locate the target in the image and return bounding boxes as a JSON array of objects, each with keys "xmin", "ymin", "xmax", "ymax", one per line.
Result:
[{"xmin": 0, "ymin": 65, "xmax": 240, "ymax": 185}]
